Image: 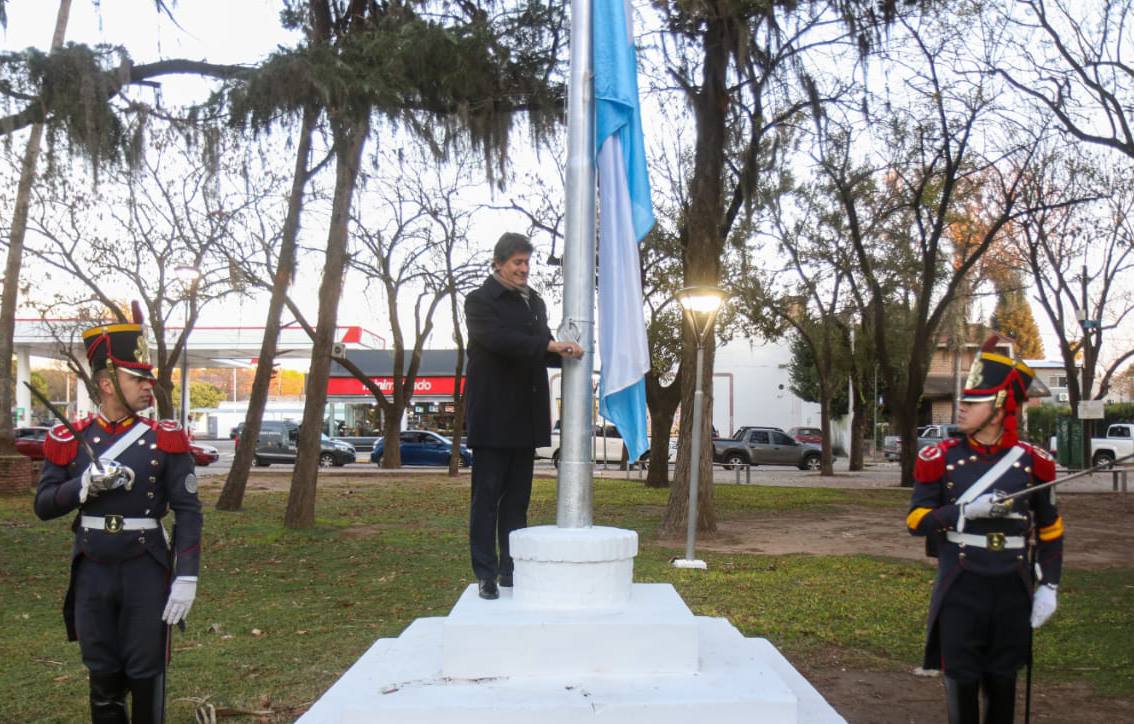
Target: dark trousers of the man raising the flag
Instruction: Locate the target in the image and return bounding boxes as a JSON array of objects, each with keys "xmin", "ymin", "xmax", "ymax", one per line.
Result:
[{"xmin": 468, "ymin": 447, "xmax": 535, "ymax": 581}]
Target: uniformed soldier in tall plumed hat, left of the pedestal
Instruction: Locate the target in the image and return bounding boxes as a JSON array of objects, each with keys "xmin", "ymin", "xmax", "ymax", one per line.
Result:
[{"xmin": 35, "ymin": 308, "xmax": 202, "ymax": 724}]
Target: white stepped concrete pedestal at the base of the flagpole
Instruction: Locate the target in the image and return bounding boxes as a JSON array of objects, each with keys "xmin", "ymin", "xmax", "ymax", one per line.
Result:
[{"xmin": 299, "ymin": 527, "xmax": 844, "ymax": 724}]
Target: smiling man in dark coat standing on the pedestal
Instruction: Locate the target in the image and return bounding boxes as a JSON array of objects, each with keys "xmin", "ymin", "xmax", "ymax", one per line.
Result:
[{"xmin": 465, "ymin": 233, "xmax": 583, "ymax": 599}]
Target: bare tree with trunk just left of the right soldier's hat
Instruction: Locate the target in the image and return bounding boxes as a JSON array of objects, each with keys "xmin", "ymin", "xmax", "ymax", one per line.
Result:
[{"xmin": 820, "ymin": 18, "xmax": 1032, "ymax": 485}]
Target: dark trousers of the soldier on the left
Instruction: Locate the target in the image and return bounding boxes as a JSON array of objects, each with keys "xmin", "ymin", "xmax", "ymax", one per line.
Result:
[{"xmin": 75, "ymin": 556, "xmax": 168, "ymax": 680}]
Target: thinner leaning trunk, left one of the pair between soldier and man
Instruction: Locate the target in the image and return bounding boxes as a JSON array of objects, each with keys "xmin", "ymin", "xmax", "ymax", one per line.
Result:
[{"xmin": 217, "ymin": 107, "xmax": 319, "ymax": 511}]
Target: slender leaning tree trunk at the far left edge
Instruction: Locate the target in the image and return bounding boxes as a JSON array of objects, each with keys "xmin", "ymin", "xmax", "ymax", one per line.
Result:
[{"xmin": 0, "ymin": 0, "xmax": 71, "ymax": 455}]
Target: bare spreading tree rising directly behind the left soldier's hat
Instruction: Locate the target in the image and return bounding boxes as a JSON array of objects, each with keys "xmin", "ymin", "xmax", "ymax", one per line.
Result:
[{"xmin": 28, "ymin": 128, "xmax": 263, "ymax": 418}]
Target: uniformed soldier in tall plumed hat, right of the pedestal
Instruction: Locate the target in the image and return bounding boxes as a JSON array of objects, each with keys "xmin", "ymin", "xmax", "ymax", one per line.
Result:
[{"xmin": 906, "ymin": 336, "xmax": 1064, "ymax": 724}]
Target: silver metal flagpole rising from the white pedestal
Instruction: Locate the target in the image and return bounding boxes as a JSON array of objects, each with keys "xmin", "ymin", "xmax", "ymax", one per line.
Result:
[{"xmin": 556, "ymin": 0, "xmax": 595, "ymax": 528}]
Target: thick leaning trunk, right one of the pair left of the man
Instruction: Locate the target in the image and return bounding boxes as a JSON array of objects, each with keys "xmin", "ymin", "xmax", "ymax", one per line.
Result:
[{"xmin": 284, "ymin": 117, "xmax": 370, "ymax": 528}]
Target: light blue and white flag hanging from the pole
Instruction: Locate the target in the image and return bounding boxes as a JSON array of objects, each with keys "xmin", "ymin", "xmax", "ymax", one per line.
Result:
[{"xmin": 592, "ymin": 0, "xmax": 653, "ymax": 462}]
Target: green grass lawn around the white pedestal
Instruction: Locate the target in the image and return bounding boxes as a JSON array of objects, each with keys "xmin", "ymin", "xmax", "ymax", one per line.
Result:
[{"xmin": 0, "ymin": 475, "xmax": 1134, "ymax": 722}]
